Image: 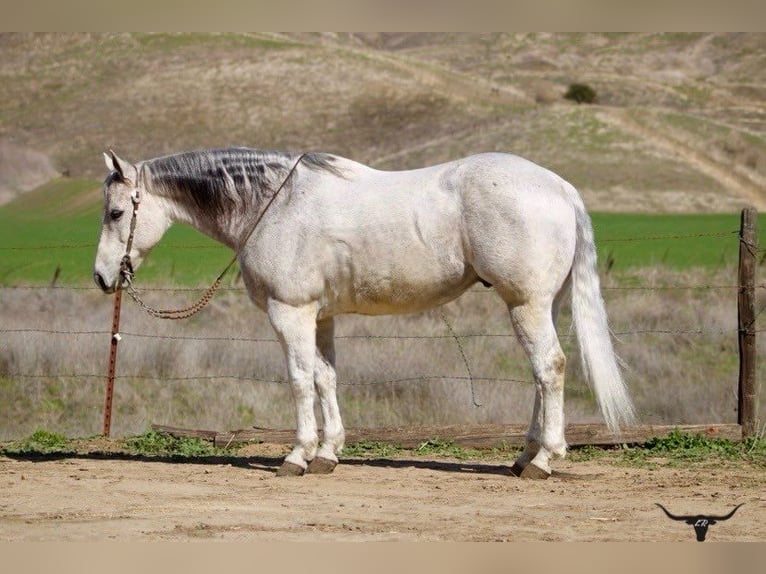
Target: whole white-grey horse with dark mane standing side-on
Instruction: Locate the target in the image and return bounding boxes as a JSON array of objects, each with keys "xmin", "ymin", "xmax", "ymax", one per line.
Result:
[{"xmin": 93, "ymin": 148, "xmax": 635, "ymax": 479}]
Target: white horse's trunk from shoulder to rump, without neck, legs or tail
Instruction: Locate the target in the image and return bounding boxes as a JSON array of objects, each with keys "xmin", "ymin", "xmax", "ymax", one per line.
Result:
[{"xmin": 249, "ymin": 154, "xmax": 574, "ymax": 314}]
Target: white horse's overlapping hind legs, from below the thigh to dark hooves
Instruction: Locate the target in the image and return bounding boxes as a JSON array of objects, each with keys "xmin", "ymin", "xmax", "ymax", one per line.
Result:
[{"xmin": 509, "ymin": 302, "xmax": 566, "ymax": 478}]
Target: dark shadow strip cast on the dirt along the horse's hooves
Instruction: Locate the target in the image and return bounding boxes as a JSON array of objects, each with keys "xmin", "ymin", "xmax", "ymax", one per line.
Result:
[{"xmin": 2, "ymin": 452, "xmax": 584, "ymax": 479}]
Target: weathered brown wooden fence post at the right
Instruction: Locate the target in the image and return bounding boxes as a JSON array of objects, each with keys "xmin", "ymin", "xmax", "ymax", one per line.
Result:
[{"xmin": 737, "ymin": 207, "xmax": 758, "ymax": 438}]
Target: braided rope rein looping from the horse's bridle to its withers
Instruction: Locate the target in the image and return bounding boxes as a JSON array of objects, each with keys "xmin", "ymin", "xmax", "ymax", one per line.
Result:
[{"xmin": 120, "ymin": 153, "xmax": 306, "ymax": 320}]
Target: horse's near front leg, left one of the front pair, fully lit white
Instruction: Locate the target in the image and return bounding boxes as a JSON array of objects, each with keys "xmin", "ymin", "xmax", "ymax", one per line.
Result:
[{"xmin": 266, "ymin": 300, "xmax": 319, "ymax": 476}]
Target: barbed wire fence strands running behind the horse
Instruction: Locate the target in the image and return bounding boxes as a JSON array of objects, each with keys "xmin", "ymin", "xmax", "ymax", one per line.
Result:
[{"xmin": 0, "ymin": 209, "xmax": 766, "ymax": 444}]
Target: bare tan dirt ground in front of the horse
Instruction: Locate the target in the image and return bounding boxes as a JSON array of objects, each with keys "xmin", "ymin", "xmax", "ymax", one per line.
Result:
[{"xmin": 0, "ymin": 445, "xmax": 766, "ymax": 542}]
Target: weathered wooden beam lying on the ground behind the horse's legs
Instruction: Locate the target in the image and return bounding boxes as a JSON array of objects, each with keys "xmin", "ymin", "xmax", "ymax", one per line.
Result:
[{"xmin": 152, "ymin": 424, "xmax": 742, "ymax": 448}]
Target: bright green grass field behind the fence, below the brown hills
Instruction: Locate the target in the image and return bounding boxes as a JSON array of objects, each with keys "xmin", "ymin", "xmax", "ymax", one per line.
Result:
[{"xmin": 0, "ymin": 179, "xmax": 766, "ymax": 286}]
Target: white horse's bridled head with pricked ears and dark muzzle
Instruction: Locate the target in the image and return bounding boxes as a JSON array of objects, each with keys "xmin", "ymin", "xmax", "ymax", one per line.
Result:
[{"xmin": 93, "ymin": 150, "xmax": 170, "ymax": 293}]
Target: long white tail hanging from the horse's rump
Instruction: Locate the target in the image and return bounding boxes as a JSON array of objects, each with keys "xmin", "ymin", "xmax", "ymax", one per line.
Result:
[{"xmin": 566, "ymin": 183, "xmax": 635, "ymax": 432}]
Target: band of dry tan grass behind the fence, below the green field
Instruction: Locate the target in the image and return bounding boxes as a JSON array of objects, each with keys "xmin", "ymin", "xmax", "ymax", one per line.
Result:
[{"xmin": 0, "ymin": 269, "xmax": 764, "ymax": 439}]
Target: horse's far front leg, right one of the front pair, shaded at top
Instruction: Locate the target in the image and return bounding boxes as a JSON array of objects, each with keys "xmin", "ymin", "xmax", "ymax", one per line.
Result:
[{"xmin": 308, "ymin": 318, "xmax": 345, "ymax": 474}]
